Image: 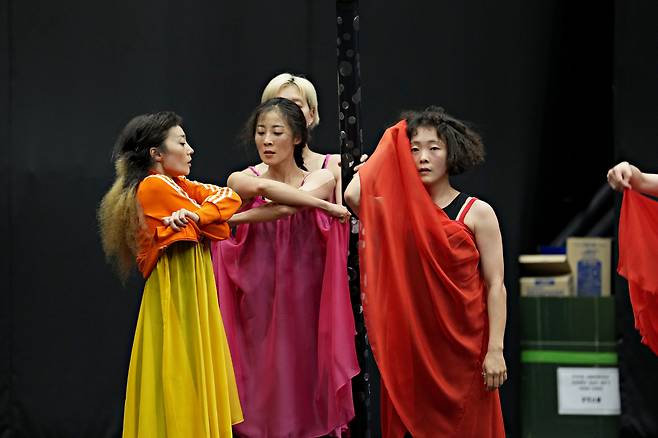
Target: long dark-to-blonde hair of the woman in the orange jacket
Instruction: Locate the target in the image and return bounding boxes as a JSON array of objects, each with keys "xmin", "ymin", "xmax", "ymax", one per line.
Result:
[{"xmin": 97, "ymin": 111, "xmax": 183, "ymax": 280}]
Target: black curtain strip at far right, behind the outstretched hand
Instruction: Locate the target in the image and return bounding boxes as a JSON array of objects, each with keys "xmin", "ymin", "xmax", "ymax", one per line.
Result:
[{"xmin": 614, "ymin": 0, "xmax": 658, "ymax": 438}]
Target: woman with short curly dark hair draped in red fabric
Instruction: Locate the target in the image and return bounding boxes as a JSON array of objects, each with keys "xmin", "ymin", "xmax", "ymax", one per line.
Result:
[{"xmin": 345, "ymin": 107, "xmax": 507, "ymax": 438}]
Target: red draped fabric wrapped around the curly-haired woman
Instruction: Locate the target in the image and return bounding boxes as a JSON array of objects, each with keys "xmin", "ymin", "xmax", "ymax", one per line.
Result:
[{"xmin": 359, "ymin": 121, "xmax": 505, "ymax": 438}]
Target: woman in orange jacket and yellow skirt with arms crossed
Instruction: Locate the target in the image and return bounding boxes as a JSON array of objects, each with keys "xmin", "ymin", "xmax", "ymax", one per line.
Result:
[{"xmin": 98, "ymin": 112, "xmax": 243, "ymax": 438}]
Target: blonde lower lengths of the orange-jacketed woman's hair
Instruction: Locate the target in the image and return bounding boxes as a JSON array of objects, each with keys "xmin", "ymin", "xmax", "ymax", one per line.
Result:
[{"xmin": 98, "ymin": 158, "xmax": 143, "ymax": 281}]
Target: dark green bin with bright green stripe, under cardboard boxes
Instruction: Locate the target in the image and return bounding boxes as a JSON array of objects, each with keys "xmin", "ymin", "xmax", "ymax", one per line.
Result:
[{"xmin": 521, "ymin": 297, "xmax": 619, "ymax": 438}]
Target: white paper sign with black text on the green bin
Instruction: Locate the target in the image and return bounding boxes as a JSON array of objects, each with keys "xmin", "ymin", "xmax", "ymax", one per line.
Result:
[{"xmin": 557, "ymin": 367, "xmax": 621, "ymax": 415}]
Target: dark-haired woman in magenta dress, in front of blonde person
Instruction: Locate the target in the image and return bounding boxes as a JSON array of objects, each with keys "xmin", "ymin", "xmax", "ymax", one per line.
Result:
[{"xmin": 213, "ymin": 98, "xmax": 359, "ymax": 438}]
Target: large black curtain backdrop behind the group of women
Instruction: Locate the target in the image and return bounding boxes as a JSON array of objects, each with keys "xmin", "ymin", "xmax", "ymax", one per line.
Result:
[{"xmin": 0, "ymin": 0, "xmax": 658, "ymax": 438}]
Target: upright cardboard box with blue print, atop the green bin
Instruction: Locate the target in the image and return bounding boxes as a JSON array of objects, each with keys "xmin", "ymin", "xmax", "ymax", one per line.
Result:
[{"xmin": 567, "ymin": 237, "xmax": 612, "ymax": 297}]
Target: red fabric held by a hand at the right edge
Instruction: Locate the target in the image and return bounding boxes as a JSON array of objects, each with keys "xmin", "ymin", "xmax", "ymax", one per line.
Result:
[{"xmin": 617, "ymin": 190, "xmax": 658, "ymax": 354}]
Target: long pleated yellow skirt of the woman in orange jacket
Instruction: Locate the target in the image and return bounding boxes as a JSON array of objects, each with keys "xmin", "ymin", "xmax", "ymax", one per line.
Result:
[{"xmin": 123, "ymin": 242, "xmax": 243, "ymax": 438}]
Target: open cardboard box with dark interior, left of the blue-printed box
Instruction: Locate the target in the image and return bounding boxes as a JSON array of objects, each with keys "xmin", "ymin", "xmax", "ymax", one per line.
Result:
[{"xmin": 519, "ymin": 254, "xmax": 573, "ymax": 297}]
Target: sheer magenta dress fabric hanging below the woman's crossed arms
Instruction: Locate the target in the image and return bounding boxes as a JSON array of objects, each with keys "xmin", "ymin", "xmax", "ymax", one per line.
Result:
[{"xmin": 212, "ymin": 198, "xmax": 359, "ymax": 437}]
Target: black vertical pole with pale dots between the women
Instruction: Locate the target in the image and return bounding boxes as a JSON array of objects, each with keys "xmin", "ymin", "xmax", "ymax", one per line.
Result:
[{"xmin": 336, "ymin": 0, "xmax": 379, "ymax": 438}]
